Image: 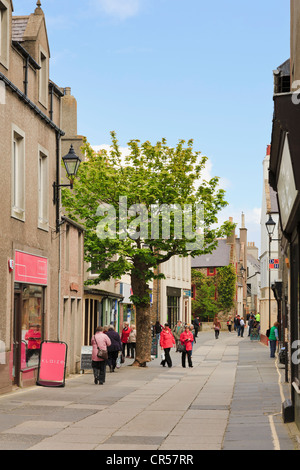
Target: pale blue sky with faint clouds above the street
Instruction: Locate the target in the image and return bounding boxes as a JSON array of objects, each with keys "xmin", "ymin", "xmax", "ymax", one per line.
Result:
[{"xmin": 13, "ymin": 0, "xmax": 290, "ymax": 253}]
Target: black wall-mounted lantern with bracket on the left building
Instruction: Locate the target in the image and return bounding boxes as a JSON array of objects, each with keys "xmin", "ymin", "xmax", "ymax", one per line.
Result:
[{"xmin": 53, "ymin": 145, "xmax": 81, "ymax": 233}]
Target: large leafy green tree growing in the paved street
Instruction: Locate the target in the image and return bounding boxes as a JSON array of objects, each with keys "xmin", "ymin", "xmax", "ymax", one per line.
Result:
[{"xmin": 63, "ymin": 132, "xmax": 232, "ymax": 366}]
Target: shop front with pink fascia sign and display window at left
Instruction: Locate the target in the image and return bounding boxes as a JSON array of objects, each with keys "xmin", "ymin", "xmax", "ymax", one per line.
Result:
[{"xmin": 10, "ymin": 251, "xmax": 48, "ymax": 386}]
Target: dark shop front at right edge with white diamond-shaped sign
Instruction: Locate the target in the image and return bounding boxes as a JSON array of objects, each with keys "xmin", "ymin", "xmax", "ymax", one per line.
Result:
[{"xmin": 269, "ymin": 93, "xmax": 300, "ymax": 429}]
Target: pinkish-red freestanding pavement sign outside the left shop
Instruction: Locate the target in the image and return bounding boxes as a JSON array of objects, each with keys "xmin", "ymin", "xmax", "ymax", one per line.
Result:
[{"xmin": 37, "ymin": 341, "xmax": 68, "ymax": 387}]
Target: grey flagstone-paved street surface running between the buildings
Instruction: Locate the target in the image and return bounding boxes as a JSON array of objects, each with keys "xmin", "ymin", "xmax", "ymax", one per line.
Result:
[{"xmin": 0, "ymin": 332, "xmax": 298, "ymax": 452}]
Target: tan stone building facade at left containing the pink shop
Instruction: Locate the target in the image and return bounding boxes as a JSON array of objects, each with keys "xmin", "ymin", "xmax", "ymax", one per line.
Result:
[{"xmin": 0, "ymin": 0, "xmax": 84, "ymax": 393}]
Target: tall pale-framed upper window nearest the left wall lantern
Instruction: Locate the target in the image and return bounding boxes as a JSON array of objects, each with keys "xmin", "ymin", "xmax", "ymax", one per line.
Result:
[{"xmin": 38, "ymin": 148, "xmax": 49, "ymax": 230}]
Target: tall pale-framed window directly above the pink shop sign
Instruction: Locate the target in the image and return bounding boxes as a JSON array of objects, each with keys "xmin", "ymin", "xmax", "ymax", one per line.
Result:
[{"xmin": 11, "ymin": 126, "xmax": 25, "ymax": 221}]
